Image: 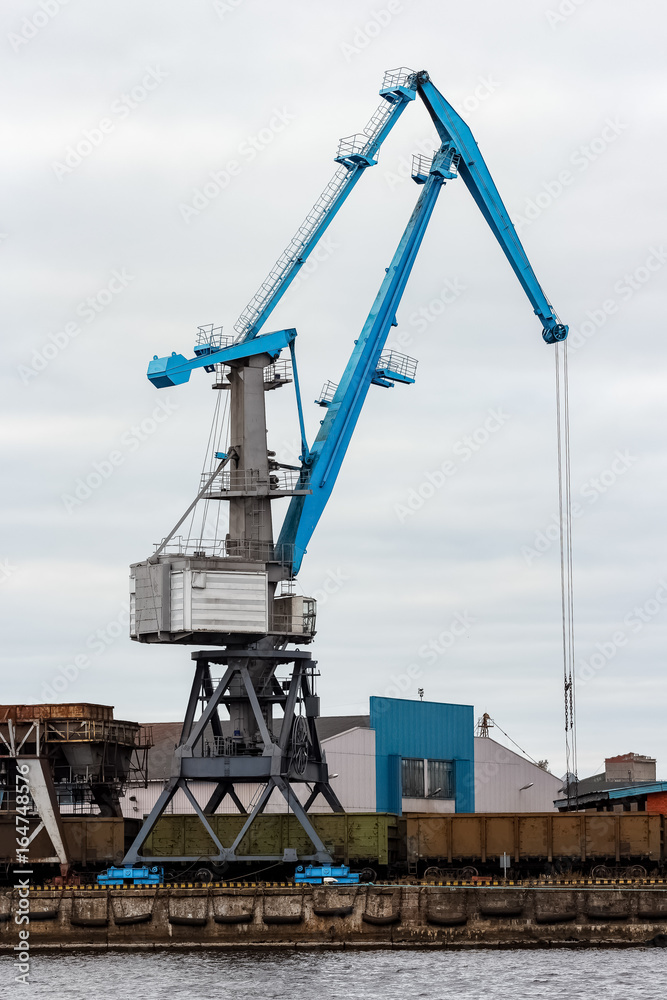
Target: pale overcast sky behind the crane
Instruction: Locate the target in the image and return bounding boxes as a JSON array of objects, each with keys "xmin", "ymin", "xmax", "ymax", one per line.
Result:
[{"xmin": 0, "ymin": 0, "xmax": 667, "ymax": 777}]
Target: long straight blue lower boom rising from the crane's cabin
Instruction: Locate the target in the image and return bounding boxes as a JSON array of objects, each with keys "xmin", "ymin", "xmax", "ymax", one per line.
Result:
[{"xmin": 278, "ymin": 150, "xmax": 446, "ymax": 574}]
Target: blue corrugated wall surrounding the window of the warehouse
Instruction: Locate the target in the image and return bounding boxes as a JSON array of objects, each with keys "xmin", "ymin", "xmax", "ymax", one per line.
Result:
[{"xmin": 370, "ymin": 697, "xmax": 475, "ymax": 812}]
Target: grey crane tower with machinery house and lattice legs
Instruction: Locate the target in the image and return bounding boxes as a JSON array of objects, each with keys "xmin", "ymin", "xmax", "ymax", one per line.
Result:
[{"xmin": 125, "ymin": 331, "xmax": 343, "ymax": 864}]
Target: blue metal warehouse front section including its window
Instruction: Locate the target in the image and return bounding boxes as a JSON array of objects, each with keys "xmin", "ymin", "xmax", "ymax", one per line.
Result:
[{"xmin": 370, "ymin": 697, "xmax": 475, "ymax": 814}]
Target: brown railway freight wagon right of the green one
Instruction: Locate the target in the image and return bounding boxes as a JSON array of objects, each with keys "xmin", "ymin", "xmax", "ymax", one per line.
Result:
[{"xmin": 403, "ymin": 812, "xmax": 665, "ymax": 877}]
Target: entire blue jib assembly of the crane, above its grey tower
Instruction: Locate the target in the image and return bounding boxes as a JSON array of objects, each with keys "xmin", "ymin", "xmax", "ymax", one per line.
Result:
[{"xmin": 148, "ymin": 68, "xmax": 568, "ymax": 575}]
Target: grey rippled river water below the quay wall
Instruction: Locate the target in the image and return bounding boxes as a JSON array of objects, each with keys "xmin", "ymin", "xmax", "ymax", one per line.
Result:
[{"xmin": 5, "ymin": 948, "xmax": 667, "ymax": 1000}]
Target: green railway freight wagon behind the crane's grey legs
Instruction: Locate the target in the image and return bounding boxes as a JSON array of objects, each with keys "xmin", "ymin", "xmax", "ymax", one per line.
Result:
[{"xmin": 142, "ymin": 813, "xmax": 404, "ymax": 870}]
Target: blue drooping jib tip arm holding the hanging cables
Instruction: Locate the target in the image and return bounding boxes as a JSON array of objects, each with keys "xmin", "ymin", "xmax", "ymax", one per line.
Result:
[{"xmin": 417, "ymin": 71, "xmax": 568, "ymax": 344}]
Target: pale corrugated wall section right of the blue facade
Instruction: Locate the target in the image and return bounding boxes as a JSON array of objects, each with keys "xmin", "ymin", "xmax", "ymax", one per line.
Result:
[{"xmin": 475, "ymin": 736, "xmax": 563, "ymax": 813}]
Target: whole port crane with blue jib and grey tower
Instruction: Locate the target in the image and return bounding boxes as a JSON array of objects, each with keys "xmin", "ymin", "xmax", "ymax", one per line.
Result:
[{"xmin": 124, "ymin": 67, "xmax": 568, "ymax": 866}]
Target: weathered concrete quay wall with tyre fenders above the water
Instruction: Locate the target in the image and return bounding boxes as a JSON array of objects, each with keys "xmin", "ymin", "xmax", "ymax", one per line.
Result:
[{"xmin": 0, "ymin": 885, "xmax": 667, "ymax": 952}]
